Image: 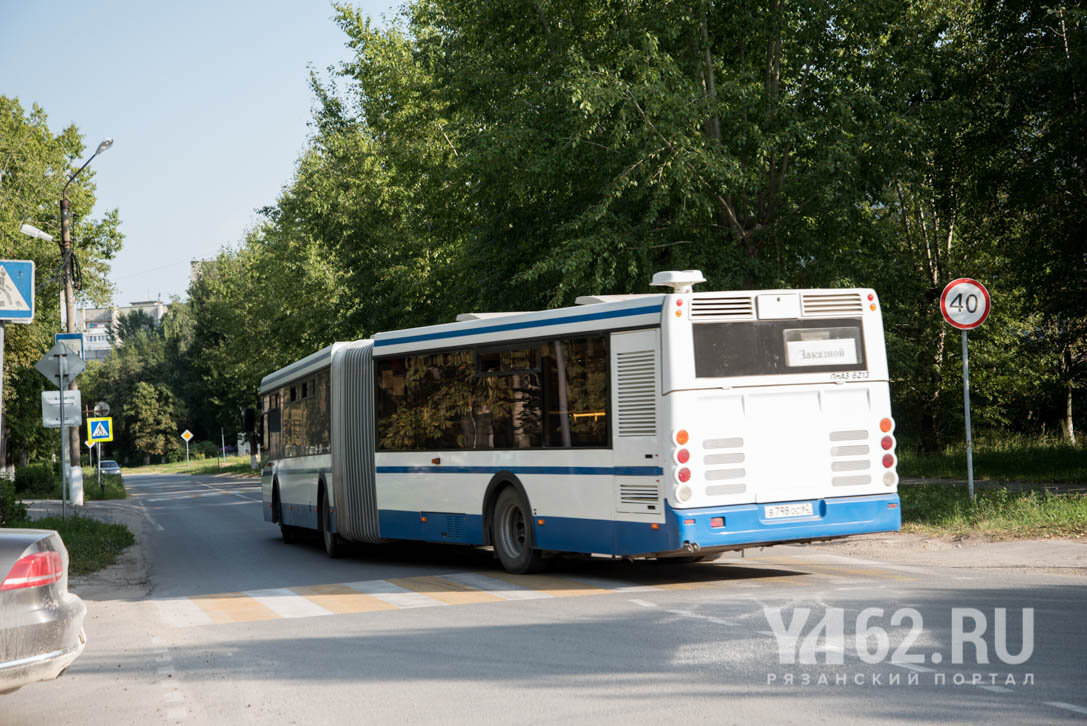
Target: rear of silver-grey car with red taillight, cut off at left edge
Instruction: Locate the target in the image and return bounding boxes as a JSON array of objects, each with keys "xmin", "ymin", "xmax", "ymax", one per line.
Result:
[{"xmin": 0, "ymin": 528, "xmax": 87, "ymax": 693}]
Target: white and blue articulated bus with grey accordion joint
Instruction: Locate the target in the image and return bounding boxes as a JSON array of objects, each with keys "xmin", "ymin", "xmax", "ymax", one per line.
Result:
[{"xmin": 260, "ymin": 271, "xmax": 901, "ymax": 573}]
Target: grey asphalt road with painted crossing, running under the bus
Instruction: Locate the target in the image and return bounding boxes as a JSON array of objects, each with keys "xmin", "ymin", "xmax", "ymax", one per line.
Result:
[{"xmin": 0, "ymin": 476, "xmax": 1087, "ymax": 726}]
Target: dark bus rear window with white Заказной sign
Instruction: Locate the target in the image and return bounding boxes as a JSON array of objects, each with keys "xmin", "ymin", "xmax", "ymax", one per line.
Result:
[{"xmin": 694, "ymin": 318, "xmax": 866, "ymax": 378}]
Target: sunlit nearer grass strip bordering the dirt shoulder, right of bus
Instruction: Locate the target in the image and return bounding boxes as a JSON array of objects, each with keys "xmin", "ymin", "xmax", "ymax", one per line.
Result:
[{"xmin": 898, "ymin": 484, "xmax": 1087, "ymax": 539}]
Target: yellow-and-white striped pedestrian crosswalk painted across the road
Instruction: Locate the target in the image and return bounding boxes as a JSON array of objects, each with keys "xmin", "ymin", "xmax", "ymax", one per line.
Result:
[{"xmin": 155, "ymin": 567, "xmax": 917, "ymax": 627}]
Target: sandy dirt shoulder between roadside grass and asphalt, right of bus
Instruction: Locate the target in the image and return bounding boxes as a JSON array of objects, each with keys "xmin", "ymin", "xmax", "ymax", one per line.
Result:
[{"xmin": 805, "ymin": 533, "xmax": 1087, "ymax": 577}]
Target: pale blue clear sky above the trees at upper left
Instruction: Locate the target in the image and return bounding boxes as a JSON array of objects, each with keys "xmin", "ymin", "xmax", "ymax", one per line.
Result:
[{"xmin": 0, "ymin": 0, "xmax": 400, "ymax": 305}]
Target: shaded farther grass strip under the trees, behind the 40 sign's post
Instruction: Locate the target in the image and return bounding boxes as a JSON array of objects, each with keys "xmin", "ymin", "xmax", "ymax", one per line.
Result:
[{"xmin": 898, "ymin": 437, "xmax": 1087, "ymax": 483}]
